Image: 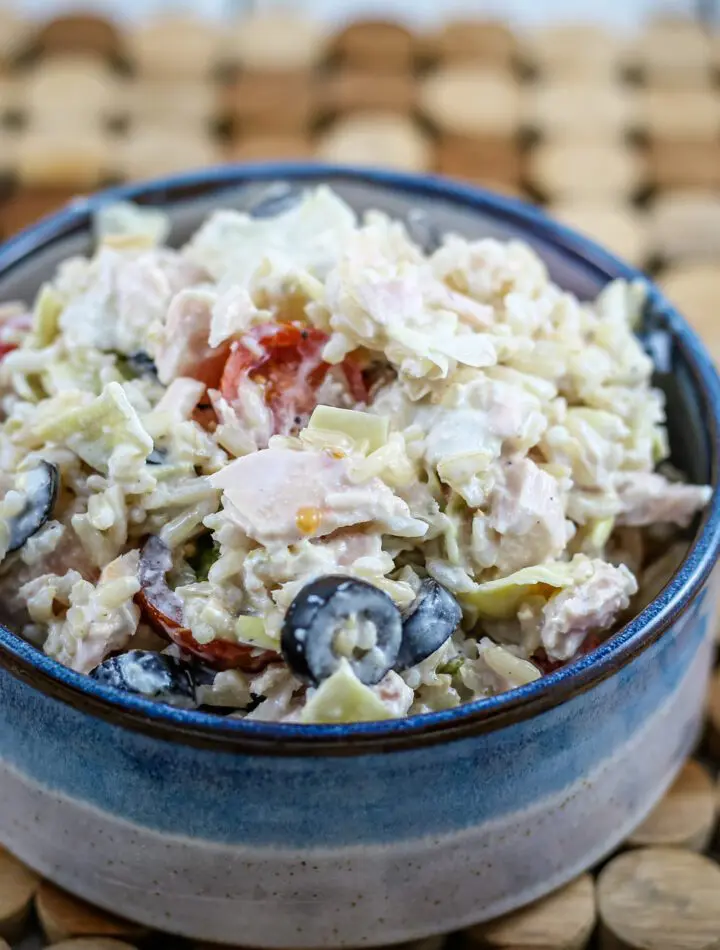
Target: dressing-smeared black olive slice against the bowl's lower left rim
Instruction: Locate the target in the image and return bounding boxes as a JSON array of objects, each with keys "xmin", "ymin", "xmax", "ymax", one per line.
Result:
[{"xmin": 90, "ymin": 650, "xmax": 197, "ymax": 709}]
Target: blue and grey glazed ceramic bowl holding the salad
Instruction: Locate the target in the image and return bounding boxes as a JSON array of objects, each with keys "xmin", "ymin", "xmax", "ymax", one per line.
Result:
[{"xmin": 0, "ymin": 165, "xmax": 720, "ymax": 948}]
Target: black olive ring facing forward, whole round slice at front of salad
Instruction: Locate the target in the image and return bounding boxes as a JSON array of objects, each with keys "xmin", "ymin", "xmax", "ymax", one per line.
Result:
[{"xmin": 280, "ymin": 576, "xmax": 402, "ymax": 685}]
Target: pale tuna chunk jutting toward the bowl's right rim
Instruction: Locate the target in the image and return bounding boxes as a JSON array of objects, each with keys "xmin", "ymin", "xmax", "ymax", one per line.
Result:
[{"xmin": 615, "ymin": 472, "xmax": 712, "ymax": 527}]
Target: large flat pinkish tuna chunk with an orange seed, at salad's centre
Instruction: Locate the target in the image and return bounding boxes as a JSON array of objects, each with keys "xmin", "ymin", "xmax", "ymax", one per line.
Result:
[{"xmin": 210, "ymin": 448, "xmax": 427, "ymax": 547}]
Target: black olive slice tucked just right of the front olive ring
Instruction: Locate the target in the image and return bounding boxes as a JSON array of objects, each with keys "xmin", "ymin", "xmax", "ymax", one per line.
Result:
[{"xmin": 395, "ymin": 578, "xmax": 462, "ymax": 670}]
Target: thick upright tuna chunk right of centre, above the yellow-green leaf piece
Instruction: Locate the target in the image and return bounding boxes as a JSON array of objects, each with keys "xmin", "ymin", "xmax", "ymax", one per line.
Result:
[{"xmin": 472, "ymin": 458, "xmax": 573, "ymax": 574}]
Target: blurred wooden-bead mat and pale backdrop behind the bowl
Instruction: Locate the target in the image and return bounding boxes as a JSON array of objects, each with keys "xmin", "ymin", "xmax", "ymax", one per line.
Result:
[{"xmin": 0, "ymin": 0, "xmax": 720, "ymax": 357}]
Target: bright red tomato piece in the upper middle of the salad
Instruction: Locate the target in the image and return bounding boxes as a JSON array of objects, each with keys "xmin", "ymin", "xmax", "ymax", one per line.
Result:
[{"xmin": 220, "ymin": 323, "xmax": 367, "ymax": 435}]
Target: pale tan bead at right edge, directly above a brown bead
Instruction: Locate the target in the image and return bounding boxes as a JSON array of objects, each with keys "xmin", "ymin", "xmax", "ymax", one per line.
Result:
[{"xmin": 637, "ymin": 89, "xmax": 720, "ymax": 142}]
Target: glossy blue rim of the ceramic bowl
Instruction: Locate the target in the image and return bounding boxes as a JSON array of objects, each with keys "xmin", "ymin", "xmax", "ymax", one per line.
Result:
[{"xmin": 0, "ymin": 162, "xmax": 720, "ymax": 756}]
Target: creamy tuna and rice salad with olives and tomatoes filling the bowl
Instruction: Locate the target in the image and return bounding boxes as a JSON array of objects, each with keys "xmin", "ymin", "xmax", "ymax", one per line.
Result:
[{"xmin": 0, "ymin": 187, "xmax": 710, "ymax": 723}]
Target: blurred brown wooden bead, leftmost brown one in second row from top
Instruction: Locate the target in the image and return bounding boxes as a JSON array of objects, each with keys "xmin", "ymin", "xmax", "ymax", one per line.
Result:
[{"xmin": 224, "ymin": 72, "xmax": 315, "ymax": 133}]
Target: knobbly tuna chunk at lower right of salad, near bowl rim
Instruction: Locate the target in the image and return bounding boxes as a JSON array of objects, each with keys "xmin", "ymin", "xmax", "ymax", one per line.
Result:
[{"xmin": 540, "ymin": 559, "xmax": 638, "ymax": 660}]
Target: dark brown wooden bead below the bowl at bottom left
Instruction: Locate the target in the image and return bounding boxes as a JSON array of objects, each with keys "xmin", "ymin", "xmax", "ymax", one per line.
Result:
[{"xmin": 35, "ymin": 881, "xmax": 147, "ymax": 943}]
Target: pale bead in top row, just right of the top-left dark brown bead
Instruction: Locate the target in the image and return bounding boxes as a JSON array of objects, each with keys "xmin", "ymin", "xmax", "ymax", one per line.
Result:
[{"xmin": 127, "ymin": 14, "xmax": 222, "ymax": 78}]
